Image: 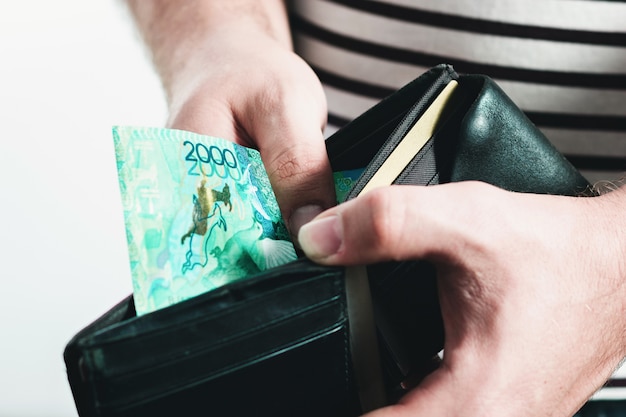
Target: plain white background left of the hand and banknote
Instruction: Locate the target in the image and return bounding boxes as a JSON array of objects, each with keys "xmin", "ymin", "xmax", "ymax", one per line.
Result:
[{"xmin": 0, "ymin": 0, "xmax": 166, "ymax": 417}]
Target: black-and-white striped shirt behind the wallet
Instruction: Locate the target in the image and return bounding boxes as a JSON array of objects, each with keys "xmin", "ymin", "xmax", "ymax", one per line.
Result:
[{"xmin": 291, "ymin": 0, "xmax": 626, "ymax": 182}]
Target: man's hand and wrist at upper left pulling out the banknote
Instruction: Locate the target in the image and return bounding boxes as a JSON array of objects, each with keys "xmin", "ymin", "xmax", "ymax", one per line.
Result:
[{"xmin": 124, "ymin": 0, "xmax": 335, "ymax": 236}]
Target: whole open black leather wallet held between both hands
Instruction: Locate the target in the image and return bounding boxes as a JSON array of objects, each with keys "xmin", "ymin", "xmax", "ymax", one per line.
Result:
[{"xmin": 64, "ymin": 65, "xmax": 589, "ymax": 417}]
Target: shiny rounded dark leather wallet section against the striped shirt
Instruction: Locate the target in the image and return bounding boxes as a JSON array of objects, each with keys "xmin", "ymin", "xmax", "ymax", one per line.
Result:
[{"xmin": 449, "ymin": 76, "xmax": 589, "ymax": 195}]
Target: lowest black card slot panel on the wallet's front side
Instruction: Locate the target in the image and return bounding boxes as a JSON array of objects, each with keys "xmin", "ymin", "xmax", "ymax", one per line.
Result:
[{"xmin": 93, "ymin": 329, "xmax": 361, "ymax": 417}]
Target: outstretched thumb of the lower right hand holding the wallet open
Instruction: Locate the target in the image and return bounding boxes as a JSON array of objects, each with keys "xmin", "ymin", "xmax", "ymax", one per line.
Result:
[{"xmin": 298, "ymin": 185, "xmax": 455, "ymax": 265}]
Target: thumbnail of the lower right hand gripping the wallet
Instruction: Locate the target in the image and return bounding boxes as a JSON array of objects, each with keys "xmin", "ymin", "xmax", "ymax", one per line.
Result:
[{"xmin": 298, "ymin": 216, "xmax": 343, "ymax": 259}]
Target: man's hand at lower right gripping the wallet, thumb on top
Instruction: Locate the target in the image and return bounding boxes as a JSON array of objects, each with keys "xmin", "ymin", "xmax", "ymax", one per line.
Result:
[{"xmin": 299, "ymin": 183, "xmax": 626, "ymax": 417}]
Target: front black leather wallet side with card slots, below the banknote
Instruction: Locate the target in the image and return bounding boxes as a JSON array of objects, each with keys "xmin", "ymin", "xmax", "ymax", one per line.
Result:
[{"xmin": 65, "ymin": 260, "xmax": 359, "ymax": 417}]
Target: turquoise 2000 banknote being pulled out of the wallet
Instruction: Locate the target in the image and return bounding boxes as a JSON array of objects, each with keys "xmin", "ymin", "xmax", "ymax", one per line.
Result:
[{"xmin": 113, "ymin": 127, "xmax": 296, "ymax": 315}]
